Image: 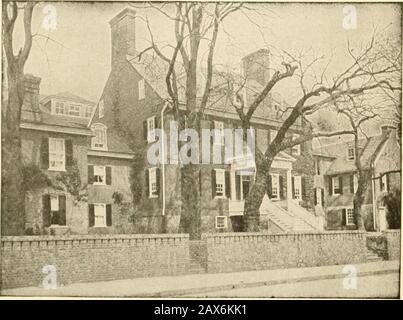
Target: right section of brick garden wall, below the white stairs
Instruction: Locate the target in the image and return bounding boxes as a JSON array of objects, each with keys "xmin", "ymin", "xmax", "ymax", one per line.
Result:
[{"xmin": 203, "ymin": 231, "xmax": 366, "ymax": 273}]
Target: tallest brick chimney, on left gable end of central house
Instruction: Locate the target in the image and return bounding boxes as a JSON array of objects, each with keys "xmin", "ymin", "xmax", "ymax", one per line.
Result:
[{"xmin": 109, "ymin": 8, "xmax": 136, "ymax": 68}]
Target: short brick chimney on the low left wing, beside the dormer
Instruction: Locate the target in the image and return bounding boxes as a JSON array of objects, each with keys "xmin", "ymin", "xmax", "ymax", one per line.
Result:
[{"xmin": 22, "ymin": 74, "xmax": 41, "ymax": 121}]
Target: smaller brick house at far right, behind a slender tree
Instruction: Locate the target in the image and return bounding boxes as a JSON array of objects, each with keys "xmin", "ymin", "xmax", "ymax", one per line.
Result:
[{"xmin": 313, "ymin": 126, "xmax": 401, "ymax": 231}]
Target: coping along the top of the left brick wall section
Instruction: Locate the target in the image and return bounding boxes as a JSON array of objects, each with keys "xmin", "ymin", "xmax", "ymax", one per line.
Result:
[{"xmin": 0, "ymin": 233, "xmax": 189, "ymax": 242}]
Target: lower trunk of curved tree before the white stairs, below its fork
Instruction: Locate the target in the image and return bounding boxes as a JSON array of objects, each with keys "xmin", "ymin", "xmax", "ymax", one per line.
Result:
[{"xmin": 244, "ymin": 149, "xmax": 272, "ymax": 232}]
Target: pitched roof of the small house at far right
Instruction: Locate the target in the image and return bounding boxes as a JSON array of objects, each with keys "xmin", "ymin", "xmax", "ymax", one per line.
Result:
[{"xmin": 313, "ymin": 135, "xmax": 388, "ymax": 175}]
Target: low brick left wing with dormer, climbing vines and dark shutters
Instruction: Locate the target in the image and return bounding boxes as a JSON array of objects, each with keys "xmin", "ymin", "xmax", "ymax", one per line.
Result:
[{"xmin": 20, "ymin": 75, "xmax": 132, "ymax": 234}]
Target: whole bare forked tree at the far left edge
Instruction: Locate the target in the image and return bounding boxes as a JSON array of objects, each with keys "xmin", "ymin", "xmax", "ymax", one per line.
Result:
[{"xmin": 1, "ymin": 1, "xmax": 35, "ymax": 235}]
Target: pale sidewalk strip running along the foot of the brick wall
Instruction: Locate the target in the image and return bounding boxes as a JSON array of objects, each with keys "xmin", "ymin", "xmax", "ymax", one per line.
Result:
[{"xmin": 1, "ymin": 261, "xmax": 400, "ymax": 298}]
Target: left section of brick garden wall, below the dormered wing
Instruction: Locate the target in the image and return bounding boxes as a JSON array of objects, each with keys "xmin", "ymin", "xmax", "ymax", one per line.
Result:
[{"xmin": 1, "ymin": 234, "xmax": 189, "ymax": 289}]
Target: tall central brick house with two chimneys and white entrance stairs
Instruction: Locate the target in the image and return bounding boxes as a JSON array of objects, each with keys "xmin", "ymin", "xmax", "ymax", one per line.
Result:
[{"xmin": 90, "ymin": 9, "xmax": 322, "ymax": 233}]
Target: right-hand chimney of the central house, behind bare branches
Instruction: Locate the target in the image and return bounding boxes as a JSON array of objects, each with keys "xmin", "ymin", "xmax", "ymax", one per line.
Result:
[{"xmin": 242, "ymin": 49, "xmax": 270, "ymax": 86}]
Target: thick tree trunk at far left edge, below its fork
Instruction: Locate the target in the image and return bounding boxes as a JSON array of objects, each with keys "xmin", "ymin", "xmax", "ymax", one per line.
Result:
[{"xmin": 1, "ymin": 70, "xmax": 25, "ymax": 235}]
